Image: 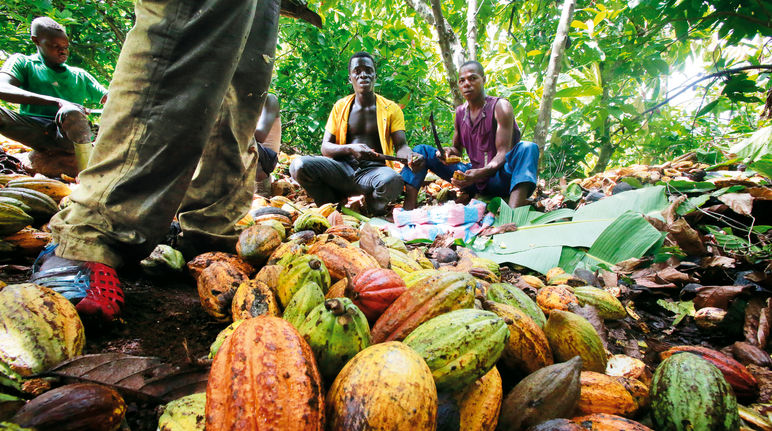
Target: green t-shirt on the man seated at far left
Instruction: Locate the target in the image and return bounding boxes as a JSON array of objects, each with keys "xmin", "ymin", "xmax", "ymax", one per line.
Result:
[{"xmin": 0, "ymin": 54, "xmax": 107, "ymax": 118}]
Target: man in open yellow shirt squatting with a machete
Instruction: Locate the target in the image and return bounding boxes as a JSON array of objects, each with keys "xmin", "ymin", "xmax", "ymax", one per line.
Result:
[{"xmin": 290, "ymin": 52, "xmax": 424, "ymax": 215}]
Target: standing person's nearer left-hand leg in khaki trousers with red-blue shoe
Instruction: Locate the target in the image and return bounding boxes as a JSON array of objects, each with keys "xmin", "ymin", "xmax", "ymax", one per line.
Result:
[{"xmin": 39, "ymin": 0, "xmax": 278, "ymax": 318}]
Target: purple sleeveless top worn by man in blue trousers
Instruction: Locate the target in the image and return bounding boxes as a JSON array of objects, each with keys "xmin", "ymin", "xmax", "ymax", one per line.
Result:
[{"xmin": 456, "ymin": 96, "xmax": 520, "ymax": 174}]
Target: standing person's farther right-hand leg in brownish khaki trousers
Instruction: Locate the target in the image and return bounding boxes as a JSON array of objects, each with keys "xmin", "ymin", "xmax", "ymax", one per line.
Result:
[{"xmin": 177, "ymin": 2, "xmax": 279, "ymax": 258}]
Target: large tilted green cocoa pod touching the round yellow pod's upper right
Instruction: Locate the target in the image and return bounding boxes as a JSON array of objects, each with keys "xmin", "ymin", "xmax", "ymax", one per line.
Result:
[{"xmin": 404, "ymin": 309, "xmax": 509, "ymax": 391}]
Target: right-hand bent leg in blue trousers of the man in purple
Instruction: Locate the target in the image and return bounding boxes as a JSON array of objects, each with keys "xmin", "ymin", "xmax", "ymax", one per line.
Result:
[{"xmin": 482, "ymin": 141, "xmax": 539, "ymax": 208}]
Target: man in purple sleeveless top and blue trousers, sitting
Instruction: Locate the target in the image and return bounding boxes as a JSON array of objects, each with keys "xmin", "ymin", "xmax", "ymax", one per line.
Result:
[{"xmin": 402, "ymin": 61, "xmax": 539, "ymax": 210}]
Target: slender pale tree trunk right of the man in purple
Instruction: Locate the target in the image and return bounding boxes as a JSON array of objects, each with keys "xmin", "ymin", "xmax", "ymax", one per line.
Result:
[{"xmin": 533, "ymin": 0, "xmax": 576, "ymax": 150}]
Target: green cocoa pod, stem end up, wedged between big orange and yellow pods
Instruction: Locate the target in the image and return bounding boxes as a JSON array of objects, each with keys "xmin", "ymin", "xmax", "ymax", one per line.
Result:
[{"xmin": 298, "ymin": 298, "xmax": 370, "ymax": 382}]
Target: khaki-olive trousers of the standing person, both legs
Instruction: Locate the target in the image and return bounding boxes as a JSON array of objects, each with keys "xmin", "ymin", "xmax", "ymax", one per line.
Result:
[{"xmin": 51, "ymin": 0, "xmax": 279, "ymax": 266}]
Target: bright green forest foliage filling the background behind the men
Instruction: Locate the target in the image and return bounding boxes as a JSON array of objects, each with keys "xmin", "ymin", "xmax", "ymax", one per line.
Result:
[{"xmin": 0, "ymin": 0, "xmax": 772, "ymax": 179}]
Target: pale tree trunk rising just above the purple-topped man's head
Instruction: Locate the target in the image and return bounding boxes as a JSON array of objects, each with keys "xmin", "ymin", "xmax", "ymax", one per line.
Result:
[{"xmin": 405, "ymin": 0, "xmax": 466, "ymax": 106}]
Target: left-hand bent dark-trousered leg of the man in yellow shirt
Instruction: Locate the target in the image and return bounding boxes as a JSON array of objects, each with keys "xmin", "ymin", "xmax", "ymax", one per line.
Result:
[{"xmin": 290, "ymin": 156, "xmax": 362, "ymax": 205}]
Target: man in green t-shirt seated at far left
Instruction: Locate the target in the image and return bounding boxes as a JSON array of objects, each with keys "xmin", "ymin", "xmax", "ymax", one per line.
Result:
[{"xmin": 0, "ymin": 17, "xmax": 107, "ymax": 176}]
